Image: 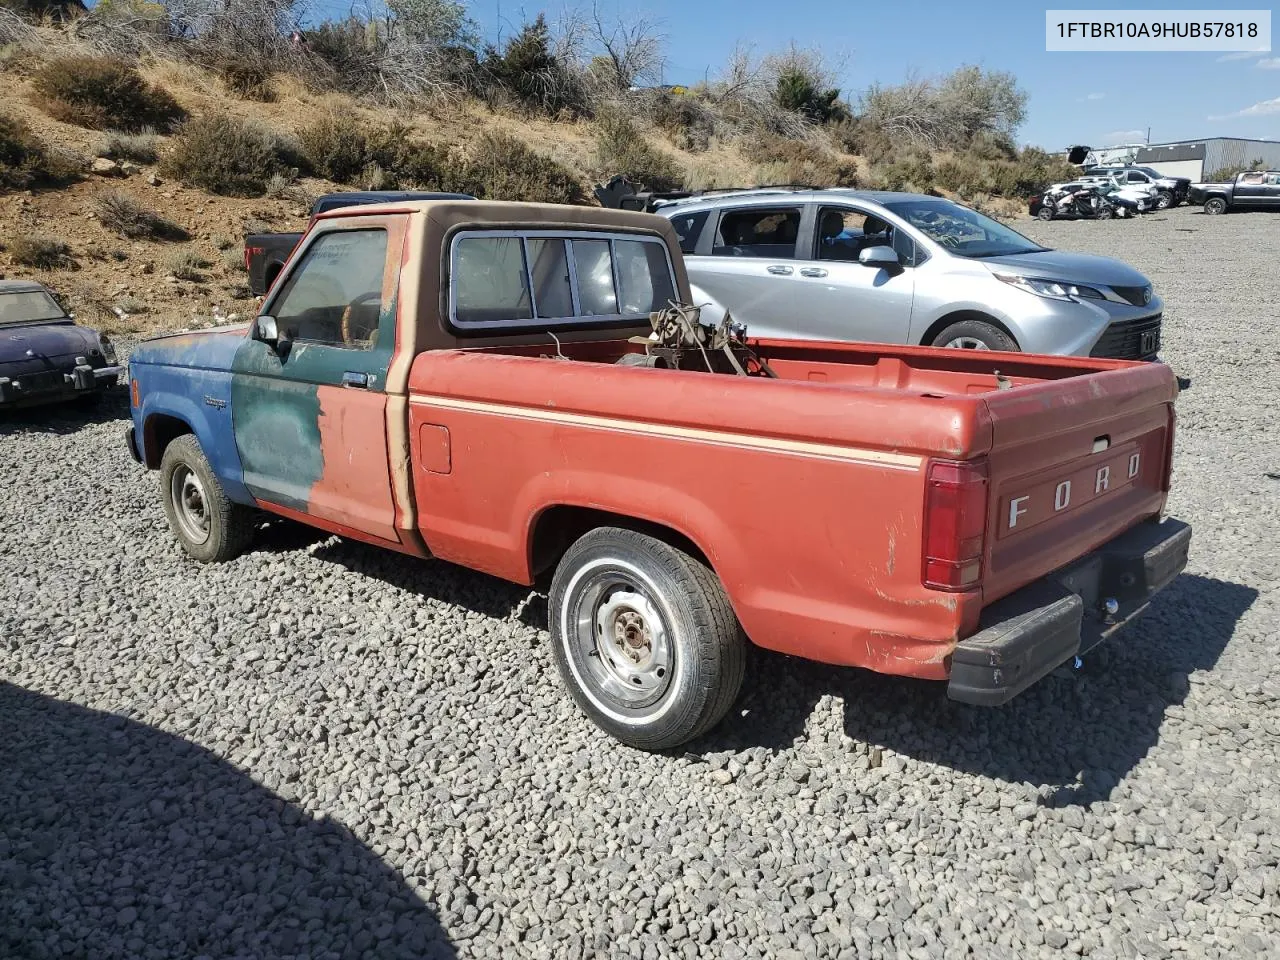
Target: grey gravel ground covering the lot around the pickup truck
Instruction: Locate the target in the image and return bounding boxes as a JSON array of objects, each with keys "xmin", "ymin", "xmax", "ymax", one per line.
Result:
[{"xmin": 0, "ymin": 210, "xmax": 1280, "ymax": 960}]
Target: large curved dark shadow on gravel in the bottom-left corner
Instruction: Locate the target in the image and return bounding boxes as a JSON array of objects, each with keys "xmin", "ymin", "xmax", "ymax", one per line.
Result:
[{"xmin": 0, "ymin": 682, "xmax": 454, "ymax": 960}]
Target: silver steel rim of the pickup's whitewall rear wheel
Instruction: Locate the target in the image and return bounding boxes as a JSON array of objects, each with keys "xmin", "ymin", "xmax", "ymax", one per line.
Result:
[{"xmin": 566, "ymin": 564, "xmax": 676, "ymax": 713}]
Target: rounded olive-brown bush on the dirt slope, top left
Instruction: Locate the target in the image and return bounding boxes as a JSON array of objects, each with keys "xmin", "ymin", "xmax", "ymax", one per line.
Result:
[{"xmin": 32, "ymin": 56, "xmax": 183, "ymax": 131}]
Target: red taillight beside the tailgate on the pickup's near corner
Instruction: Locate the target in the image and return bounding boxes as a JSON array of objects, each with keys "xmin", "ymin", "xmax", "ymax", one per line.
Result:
[{"xmin": 922, "ymin": 460, "xmax": 987, "ymax": 590}]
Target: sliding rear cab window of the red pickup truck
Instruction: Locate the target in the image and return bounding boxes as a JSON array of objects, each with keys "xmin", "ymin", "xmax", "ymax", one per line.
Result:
[{"xmin": 449, "ymin": 230, "xmax": 676, "ymax": 332}]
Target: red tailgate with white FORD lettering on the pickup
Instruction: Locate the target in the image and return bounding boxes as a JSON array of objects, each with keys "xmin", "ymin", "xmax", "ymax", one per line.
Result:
[{"xmin": 983, "ymin": 364, "xmax": 1178, "ymax": 603}]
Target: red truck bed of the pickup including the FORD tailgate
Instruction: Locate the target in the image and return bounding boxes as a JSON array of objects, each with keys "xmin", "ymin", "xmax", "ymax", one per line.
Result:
[{"xmin": 408, "ymin": 340, "xmax": 1176, "ymax": 678}]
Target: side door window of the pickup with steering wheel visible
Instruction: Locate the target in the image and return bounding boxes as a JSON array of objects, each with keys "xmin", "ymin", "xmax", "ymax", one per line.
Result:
[{"xmin": 271, "ymin": 229, "xmax": 387, "ymax": 349}]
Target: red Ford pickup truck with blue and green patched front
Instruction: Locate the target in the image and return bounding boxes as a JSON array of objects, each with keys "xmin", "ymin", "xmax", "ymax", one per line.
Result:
[{"xmin": 129, "ymin": 201, "xmax": 1190, "ymax": 749}]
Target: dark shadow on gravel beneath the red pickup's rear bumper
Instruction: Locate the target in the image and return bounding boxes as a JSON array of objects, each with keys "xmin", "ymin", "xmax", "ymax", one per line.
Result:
[{"xmin": 706, "ymin": 575, "xmax": 1258, "ymax": 806}]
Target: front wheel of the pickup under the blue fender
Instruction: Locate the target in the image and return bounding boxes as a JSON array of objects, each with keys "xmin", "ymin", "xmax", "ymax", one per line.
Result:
[{"xmin": 160, "ymin": 434, "xmax": 253, "ymax": 563}]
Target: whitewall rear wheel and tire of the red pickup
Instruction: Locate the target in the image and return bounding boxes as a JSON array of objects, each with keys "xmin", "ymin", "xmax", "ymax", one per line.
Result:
[{"xmin": 549, "ymin": 527, "xmax": 746, "ymax": 750}]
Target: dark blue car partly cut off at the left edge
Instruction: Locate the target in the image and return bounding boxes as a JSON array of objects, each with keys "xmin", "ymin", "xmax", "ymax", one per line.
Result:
[{"xmin": 0, "ymin": 280, "xmax": 123, "ymax": 410}]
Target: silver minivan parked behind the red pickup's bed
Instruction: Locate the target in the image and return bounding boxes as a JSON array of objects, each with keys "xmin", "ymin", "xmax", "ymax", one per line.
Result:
[{"xmin": 655, "ymin": 188, "xmax": 1162, "ymax": 360}]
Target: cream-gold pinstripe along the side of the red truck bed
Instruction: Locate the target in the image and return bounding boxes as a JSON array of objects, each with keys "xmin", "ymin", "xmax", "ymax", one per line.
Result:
[{"xmin": 410, "ymin": 394, "xmax": 923, "ymax": 471}]
